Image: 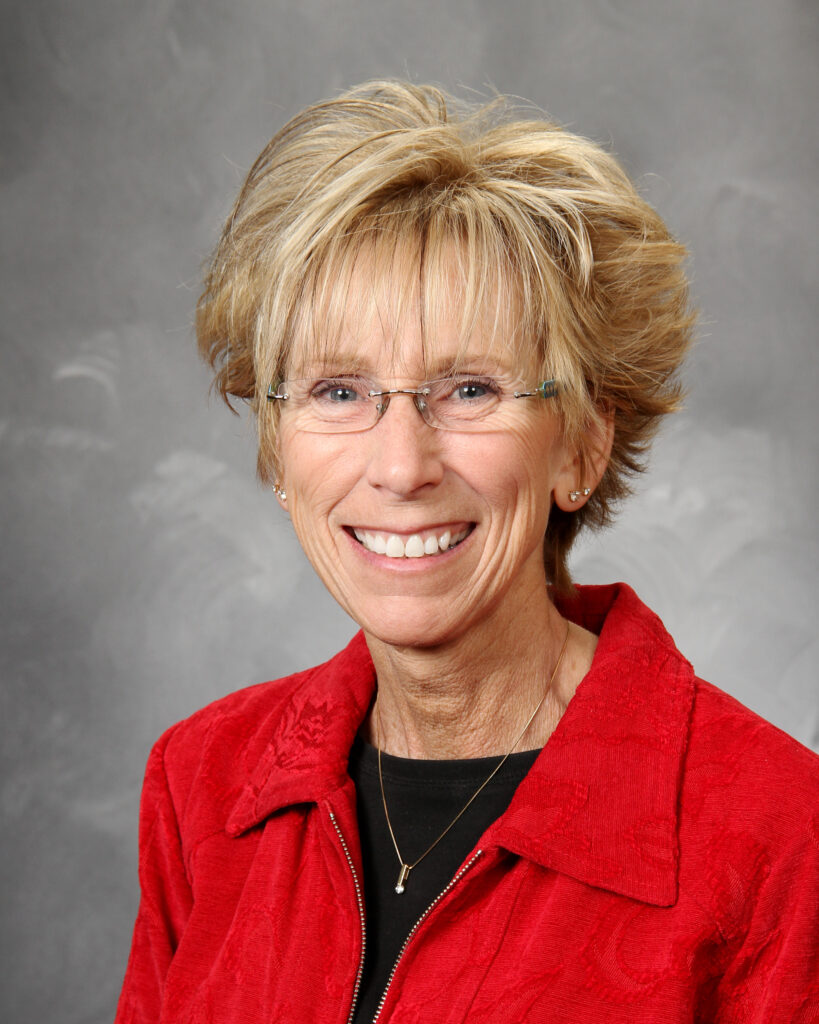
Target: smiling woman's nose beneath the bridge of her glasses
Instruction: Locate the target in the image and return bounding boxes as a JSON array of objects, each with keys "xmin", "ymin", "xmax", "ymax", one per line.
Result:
[{"xmin": 367, "ymin": 392, "xmax": 443, "ymax": 498}]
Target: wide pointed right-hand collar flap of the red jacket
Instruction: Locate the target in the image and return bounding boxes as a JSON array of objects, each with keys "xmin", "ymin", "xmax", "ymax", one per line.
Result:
[{"xmin": 486, "ymin": 584, "xmax": 694, "ymax": 906}]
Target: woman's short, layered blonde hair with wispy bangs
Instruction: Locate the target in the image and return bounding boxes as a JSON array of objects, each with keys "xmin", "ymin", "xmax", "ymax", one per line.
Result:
[{"xmin": 197, "ymin": 81, "xmax": 694, "ymax": 592}]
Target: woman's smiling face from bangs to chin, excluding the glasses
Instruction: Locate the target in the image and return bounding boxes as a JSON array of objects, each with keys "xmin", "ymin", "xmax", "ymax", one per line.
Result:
[{"xmin": 279, "ymin": 284, "xmax": 576, "ymax": 647}]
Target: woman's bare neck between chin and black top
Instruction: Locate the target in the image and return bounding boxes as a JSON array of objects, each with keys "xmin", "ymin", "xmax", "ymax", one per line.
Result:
[{"xmin": 364, "ymin": 587, "xmax": 597, "ymax": 760}]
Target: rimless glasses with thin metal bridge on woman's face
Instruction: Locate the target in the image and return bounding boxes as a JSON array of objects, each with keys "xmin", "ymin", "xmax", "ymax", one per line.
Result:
[{"xmin": 267, "ymin": 375, "xmax": 558, "ymax": 434}]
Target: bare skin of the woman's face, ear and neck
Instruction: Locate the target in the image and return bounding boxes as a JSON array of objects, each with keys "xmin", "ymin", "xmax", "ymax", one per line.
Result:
[{"xmin": 278, "ymin": 284, "xmax": 611, "ymax": 759}]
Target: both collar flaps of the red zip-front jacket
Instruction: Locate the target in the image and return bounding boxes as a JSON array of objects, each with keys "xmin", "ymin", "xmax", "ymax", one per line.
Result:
[{"xmin": 227, "ymin": 584, "xmax": 694, "ymax": 906}]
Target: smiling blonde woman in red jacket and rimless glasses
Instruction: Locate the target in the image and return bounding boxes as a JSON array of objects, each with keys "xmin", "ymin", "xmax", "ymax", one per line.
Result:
[{"xmin": 118, "ymin": 83, "xmax": 819, "ymax": 1024}]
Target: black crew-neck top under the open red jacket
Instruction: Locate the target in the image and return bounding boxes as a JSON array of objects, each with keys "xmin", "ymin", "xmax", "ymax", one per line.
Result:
[{"xmin": 349, "ymin": 739, "xmax": 541, "ymax": 1024}]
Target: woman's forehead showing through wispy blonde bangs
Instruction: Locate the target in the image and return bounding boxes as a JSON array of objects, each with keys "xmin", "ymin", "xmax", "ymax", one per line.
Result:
[{"xmin": 287, "ymin": 240, "xmax": 536, "ymax": 378}]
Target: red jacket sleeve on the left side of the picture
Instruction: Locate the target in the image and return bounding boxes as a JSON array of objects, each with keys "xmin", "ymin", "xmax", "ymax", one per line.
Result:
[{"xmin": 116, "ymin": 729, "xmax": 192, "ymax": 1024}]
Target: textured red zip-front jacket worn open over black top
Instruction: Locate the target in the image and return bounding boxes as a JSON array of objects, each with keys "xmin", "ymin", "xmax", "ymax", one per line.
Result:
[{"xmin": 117, "ymin": 585, "xmax": 819, "ymax": 1024}]
